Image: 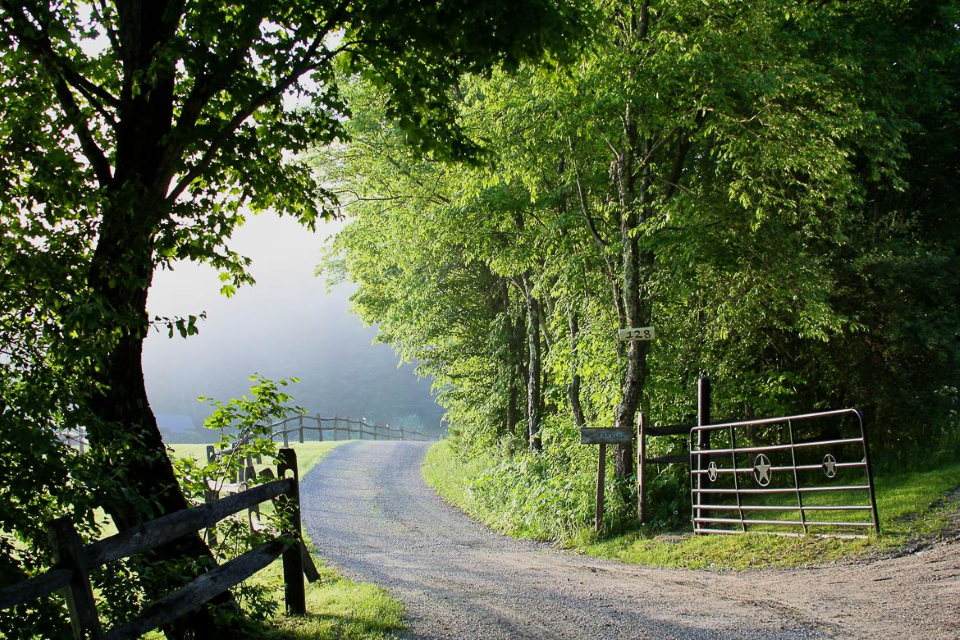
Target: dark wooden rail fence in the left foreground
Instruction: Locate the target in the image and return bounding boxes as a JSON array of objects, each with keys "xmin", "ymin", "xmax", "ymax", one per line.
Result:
[{"xmin": 0, "ymin": 448, "xmax": 315, "ymax": 640}]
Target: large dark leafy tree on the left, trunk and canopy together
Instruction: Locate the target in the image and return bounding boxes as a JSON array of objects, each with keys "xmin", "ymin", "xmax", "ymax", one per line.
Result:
[{"xmin": 0, "ymin": 0, "xmax": 579, "ymax": 638}]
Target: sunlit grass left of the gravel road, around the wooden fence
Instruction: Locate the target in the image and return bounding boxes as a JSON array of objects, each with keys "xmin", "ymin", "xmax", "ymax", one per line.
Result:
[{"xmin": 137, "ymin": 441, "xmax": 404, "ymax": 640}]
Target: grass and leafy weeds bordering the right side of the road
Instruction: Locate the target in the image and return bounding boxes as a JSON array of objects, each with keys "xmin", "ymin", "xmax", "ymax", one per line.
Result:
[{"xmin": 423, "ymin": 442, "xmax": 960, "ymax": 570}]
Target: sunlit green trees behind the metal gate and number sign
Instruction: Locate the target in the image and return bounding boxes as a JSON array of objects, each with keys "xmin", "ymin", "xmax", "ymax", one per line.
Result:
[{"xmin": 324, "ymin": 0, "xmax": 960, "ymax": 532}]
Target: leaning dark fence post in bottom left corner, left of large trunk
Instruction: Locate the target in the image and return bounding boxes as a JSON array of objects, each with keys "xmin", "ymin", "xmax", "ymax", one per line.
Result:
[{"xmin": 48, "ymin": 518, "xmax": 103, "ymax": 640}]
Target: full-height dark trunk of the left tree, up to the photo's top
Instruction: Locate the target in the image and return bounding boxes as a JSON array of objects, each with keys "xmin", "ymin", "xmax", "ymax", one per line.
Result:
[{"xmin": 88, "ymin": 2, "xmax": 240, "ymax": 624}]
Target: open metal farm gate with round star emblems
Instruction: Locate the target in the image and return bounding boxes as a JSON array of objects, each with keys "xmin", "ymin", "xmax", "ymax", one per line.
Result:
[{"xmin": 690, "ymin": 409, "xmax": 880, "ymax": 537}]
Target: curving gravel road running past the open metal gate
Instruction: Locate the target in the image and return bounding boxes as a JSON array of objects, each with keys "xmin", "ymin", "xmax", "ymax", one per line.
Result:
[{"xmin": 301, "ymin": 442, "xmax": 960, "ymax": 640}]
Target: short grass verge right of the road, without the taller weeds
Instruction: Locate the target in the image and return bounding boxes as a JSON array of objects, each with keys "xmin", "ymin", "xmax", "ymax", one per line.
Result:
[{"xmin": 423, "ymin": 443, "xmax": 960, "ymax": 570}]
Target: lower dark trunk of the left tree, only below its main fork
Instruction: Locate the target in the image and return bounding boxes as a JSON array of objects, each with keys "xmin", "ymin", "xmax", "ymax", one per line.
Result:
[{"xmin": 89, "ymin": 198, "xmax": 239, "ymax": 638}]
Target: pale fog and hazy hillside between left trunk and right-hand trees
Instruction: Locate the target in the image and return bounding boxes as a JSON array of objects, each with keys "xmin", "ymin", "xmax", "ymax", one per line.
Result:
[{"xmin": 143, "ymin": 214, "xmax": 442, "ymax": 440}]
